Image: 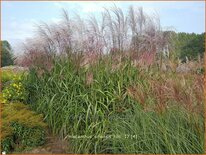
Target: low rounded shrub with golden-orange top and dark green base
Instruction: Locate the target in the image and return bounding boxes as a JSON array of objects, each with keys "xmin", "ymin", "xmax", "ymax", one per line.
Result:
[{"xmin": 1, "ymin": 103, "xmax": 46, "ymax": 153}]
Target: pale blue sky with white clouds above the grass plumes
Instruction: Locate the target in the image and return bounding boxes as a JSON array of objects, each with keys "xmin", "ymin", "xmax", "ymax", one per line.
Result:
[{"xmin": 1, "ymin": 1, "xmax": 205, "ymax": 53}]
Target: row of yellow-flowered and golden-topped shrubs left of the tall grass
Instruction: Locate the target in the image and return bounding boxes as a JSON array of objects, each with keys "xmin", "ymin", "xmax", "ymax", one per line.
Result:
[{"xmin": 0, "ymin": 70, "xmax": 46, "ymax": 153}]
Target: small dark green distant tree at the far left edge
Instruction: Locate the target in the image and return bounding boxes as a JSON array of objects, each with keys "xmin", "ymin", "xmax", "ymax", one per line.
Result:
[{"xmin": 1, "ymin": 41, "xmax": 14, "ymax": 67}]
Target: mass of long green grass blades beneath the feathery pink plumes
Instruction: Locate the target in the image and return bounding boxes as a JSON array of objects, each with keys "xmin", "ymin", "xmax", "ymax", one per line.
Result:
[{"xmin": 26, "ymin": 57, "xmax": 204, "ymax": 154}]
